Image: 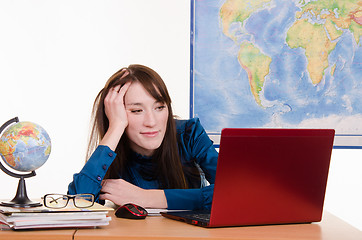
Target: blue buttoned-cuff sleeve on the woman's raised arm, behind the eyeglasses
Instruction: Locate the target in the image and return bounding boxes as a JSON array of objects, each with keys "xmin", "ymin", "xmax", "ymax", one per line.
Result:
[{"xmin": 68, "ymin": 145, "xmax": 116, "ymax": 202}]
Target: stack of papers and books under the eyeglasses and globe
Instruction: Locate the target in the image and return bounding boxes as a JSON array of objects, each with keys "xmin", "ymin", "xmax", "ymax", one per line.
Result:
[{"xmin": 0, "ymin": 203, "xmax": 113, "ymax": 230}]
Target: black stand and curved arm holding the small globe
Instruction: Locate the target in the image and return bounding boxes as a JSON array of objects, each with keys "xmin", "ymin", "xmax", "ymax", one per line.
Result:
[{"xmin": 0, "ymin": 117, "xmax": 42, "ymax": 208}]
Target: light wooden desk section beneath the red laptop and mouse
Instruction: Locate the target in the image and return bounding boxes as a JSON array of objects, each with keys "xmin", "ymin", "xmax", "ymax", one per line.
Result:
[{"xmin": 74, "ymin": 213, "xmax": 362, "ymax": 240}]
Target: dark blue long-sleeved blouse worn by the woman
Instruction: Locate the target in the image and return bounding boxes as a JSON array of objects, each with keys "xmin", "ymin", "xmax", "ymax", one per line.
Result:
[{"xmin": 68, "ymin": 118, "xmax": 218, "ymax": 210}]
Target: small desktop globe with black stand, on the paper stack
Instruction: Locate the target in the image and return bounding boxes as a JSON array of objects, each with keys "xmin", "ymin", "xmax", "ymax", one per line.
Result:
[{"xmin": 0, "ymin": 117, "xmax": 51, "ymax": 207}]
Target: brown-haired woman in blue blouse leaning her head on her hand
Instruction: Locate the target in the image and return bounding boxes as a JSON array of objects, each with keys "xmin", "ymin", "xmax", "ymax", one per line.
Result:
[{"xmin": 68, "ymin": 65, "xmax": 218, "ymax": 210}]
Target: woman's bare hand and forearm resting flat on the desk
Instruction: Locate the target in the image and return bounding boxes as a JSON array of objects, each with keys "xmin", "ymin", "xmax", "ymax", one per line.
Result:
[{"xmin": 99, "ymin": 179, "xmax": 167, "ymax": 208}]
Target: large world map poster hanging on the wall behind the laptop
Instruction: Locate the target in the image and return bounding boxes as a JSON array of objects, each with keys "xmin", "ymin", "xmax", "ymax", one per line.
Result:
[{"xmin": 190, "ymin": 0, "xmax": 362, "ymax": 148}]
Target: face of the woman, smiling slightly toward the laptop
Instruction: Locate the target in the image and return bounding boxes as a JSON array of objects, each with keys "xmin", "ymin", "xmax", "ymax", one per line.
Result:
[{"xmin": 124, "ymin": 82, "xmax": 168, "ymax": 156}]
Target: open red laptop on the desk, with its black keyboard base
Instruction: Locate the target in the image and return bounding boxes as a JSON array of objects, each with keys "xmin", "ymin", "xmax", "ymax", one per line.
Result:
[{"xmin": 161, "ymin": 128, "xmax": 335, "ymax": 227}]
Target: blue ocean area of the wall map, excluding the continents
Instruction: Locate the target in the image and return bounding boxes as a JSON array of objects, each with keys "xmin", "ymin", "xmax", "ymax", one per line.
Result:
[{"xmin": 191, "ymin": 0, "xmax": 362, "ymax": 138}]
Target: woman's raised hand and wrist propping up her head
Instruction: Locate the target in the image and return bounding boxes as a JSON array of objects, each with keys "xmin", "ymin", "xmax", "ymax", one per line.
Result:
[{"xmin": 99, "ymin": 82, "xmax": 131, "ymax": 151}]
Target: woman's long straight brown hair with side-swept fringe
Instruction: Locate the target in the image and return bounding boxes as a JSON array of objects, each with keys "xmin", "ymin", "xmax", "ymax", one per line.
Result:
[{"xmin": 87, "ymin": 65, "xmax": 188, "ymax": 188}]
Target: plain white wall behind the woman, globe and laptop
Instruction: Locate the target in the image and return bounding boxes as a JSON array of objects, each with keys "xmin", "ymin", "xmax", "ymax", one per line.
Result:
[{"xmin": 0, "ymin": 0, "xmax": 362, "ymax": 232}]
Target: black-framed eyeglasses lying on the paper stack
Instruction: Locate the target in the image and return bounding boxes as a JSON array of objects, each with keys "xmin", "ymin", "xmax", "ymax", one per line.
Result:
[{"xmin": 42, "ymin": 193, "xmax": 94, "ymax": 208}]
